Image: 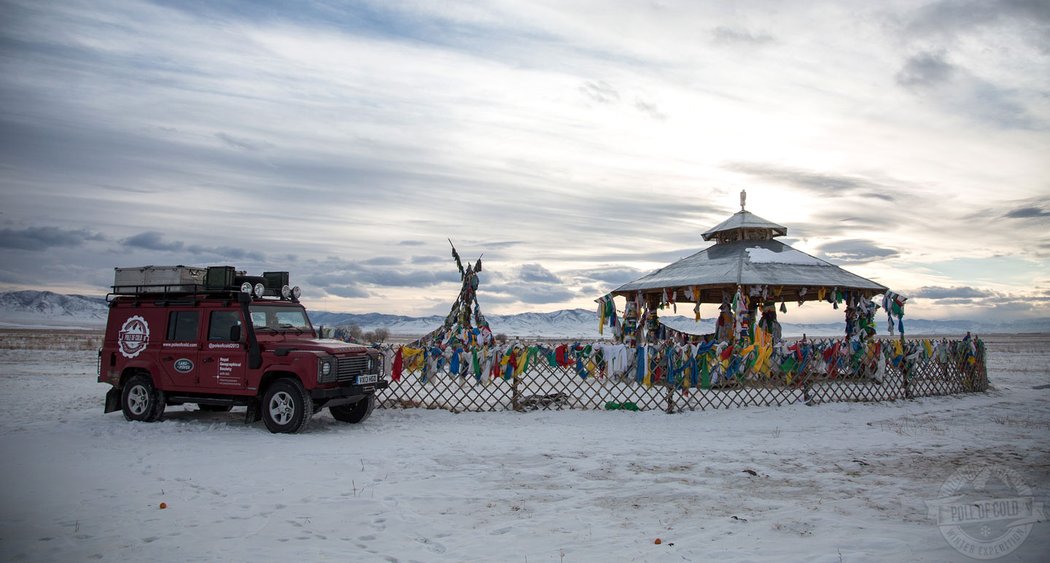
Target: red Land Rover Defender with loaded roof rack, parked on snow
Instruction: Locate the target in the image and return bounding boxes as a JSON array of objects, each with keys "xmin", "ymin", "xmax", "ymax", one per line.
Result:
[{"xmin": 99, "ymin": 266, "xmax": 387, "ymax": 433}]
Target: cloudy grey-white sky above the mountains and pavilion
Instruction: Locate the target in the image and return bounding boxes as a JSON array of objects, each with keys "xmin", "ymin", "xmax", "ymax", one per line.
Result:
[{"xmin": 0, "ymin": 0, "xmax": 1050, "ymax": 321}]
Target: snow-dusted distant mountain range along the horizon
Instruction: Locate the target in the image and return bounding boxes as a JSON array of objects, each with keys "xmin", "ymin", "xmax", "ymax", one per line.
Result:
[{"xmin": 0, "ymin": 291, "xmax": 1050, "ymax": 339}]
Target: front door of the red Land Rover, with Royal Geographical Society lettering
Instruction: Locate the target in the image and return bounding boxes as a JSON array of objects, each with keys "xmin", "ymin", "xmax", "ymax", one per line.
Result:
[{"xmin": 200, "ymin": 309, "xmax": 248, "ymax": 393}]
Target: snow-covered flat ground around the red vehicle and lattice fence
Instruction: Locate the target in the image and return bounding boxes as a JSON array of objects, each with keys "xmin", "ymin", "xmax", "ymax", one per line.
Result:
[{"xmin": 0, "ymin": 334, "xmax": 1050, "ymax": 562}]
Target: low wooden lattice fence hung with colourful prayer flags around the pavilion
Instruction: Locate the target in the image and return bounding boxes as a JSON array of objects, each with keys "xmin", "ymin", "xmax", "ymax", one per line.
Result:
[{"xmin": 378, "ymin": 338, "xmax": 988, "ymax": 413}]
